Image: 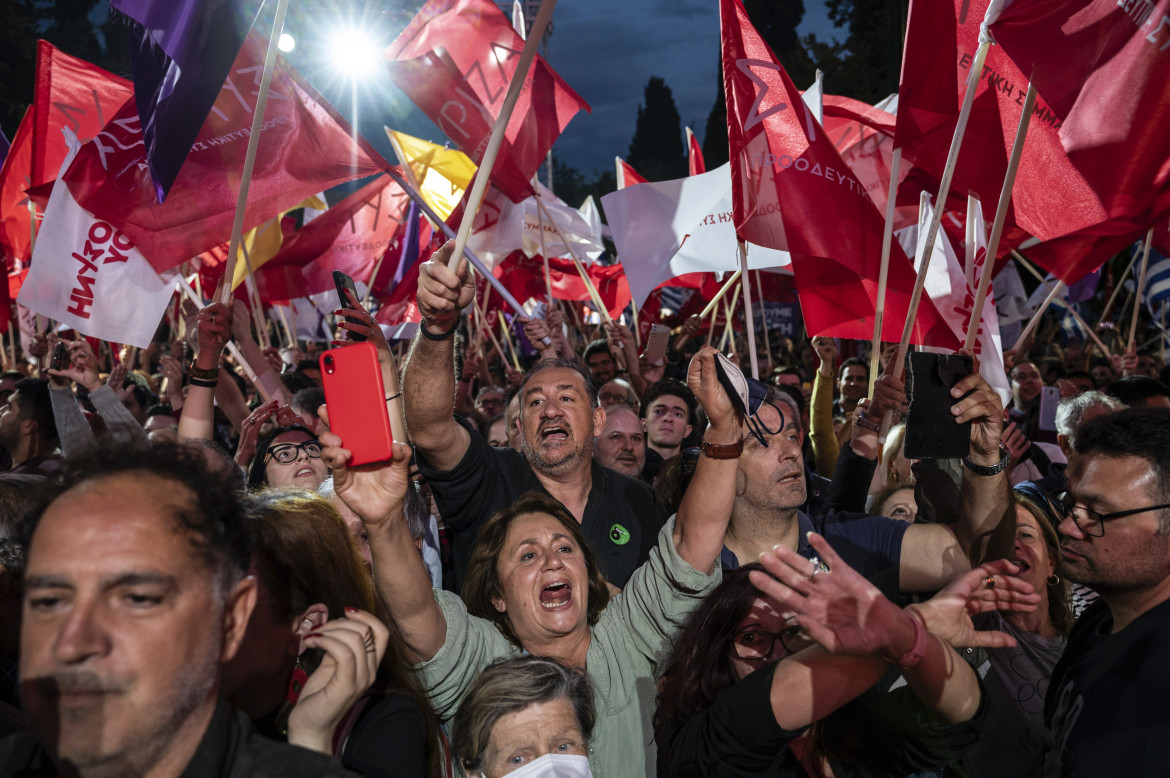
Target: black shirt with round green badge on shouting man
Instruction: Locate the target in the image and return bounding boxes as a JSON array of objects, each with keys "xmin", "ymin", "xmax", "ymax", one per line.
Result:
[{"xmin": 417, "ymin": 416, "xmax": 667, "ymax": 591}]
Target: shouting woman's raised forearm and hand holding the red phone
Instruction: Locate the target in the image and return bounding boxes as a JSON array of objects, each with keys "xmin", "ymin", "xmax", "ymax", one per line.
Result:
[{"xmin": 321, "ymin": 430, "xmax": 447, "ymax": 665}]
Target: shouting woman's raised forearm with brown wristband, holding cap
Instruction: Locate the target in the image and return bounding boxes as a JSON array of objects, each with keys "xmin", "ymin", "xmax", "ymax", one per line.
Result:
[{"xmin": 674, "ymin": 346, "xmax": 743, "ymax": 573}]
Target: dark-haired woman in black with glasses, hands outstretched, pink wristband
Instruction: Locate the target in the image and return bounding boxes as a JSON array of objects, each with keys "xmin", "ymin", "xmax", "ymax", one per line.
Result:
[{"xmin": 655, "ymin": 535, "xmax": 1037, "ymax": 778}]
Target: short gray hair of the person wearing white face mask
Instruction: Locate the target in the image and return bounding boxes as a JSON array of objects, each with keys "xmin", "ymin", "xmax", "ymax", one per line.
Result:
[{"xmin": 452, "ymin": 656, "xmax": 597, "ymax": 771}]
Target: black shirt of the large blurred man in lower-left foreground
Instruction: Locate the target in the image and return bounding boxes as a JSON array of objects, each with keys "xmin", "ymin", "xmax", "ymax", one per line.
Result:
[{"xmin": 0, "ymin": 700, "xmax": 357, "ymax": 778}]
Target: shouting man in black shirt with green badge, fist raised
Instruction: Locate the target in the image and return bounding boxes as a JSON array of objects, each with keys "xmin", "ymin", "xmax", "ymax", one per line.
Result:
[{"xmin": 402, "ymin": 242, "xmax": 667, "ymax": 588}]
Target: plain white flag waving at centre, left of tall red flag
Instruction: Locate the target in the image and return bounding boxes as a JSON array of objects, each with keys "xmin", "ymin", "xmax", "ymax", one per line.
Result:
[{"xmin": 601, "ymin": 164, "xmax": 792, "ymax": 308}]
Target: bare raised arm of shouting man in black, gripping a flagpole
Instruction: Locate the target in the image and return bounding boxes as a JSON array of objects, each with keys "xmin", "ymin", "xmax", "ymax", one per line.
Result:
[{"xmin": 402, "ymin": 241, "xmax": 475, "ymax": 470}]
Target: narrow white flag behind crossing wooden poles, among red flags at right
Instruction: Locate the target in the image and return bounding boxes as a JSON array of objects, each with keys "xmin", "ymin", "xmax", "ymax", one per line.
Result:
[{"xmin": 897, "ymin": 197, "xmax": 1011, "ymax": 405}]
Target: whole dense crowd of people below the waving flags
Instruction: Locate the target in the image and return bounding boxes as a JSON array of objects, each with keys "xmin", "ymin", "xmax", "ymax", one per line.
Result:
[{"xmin": 0, "ymin": 238, "xmax": 1170, "ymax": 778}]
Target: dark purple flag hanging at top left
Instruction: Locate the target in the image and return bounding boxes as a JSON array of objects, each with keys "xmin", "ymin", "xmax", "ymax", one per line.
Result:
[{"xmin": 110, "ymin": 0, "xmax": 264, "ymax": 202}]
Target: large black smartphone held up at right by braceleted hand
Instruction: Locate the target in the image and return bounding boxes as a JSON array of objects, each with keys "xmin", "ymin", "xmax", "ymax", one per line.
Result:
[{"xmin": 903, "ymin": 351, "xmax": 975, "ymax": 460}]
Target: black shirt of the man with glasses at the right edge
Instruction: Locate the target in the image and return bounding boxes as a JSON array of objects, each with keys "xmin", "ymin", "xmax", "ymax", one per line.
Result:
[{"xmin": 1041, "ymin": 596, "xmax": 1170, "ymax": 776}]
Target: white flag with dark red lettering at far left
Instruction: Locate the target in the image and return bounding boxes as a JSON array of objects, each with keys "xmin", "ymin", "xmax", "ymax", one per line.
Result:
[{"xmin": 18, "ymin": 140, "xmax": 178, "ymax": 349}]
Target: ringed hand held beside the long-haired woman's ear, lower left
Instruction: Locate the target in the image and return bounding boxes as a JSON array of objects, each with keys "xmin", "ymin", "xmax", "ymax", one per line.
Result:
[{"xmin": 288, "ymin": 608, "xmax": 390, "ymax": 753}]
